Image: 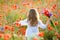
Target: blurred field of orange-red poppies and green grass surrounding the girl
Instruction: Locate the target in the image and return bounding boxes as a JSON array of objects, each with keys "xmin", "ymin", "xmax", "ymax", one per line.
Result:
[{"xmin": 0, "ymin": 0, "xmax": 60, "ymax": 40}]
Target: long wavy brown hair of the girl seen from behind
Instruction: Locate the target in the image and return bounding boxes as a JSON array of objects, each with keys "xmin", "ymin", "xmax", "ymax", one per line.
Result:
[{"xmin": 28, "ymin": 9, "xmax": 38, "ymax": 26}]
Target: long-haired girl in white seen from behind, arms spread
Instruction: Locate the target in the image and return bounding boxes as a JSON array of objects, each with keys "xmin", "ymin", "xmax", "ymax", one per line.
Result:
[{"xmin": 19, "ymin": 8, "xmax": 50, "ymax": 40}]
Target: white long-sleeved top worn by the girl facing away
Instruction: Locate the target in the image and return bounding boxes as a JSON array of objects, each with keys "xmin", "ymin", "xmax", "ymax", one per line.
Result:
[{"xmin": 19, "ymin": 19, "xmax": 46, "ymax": 37}]
